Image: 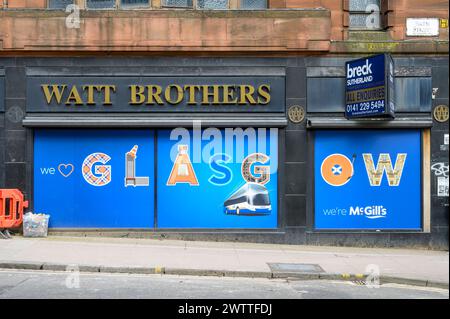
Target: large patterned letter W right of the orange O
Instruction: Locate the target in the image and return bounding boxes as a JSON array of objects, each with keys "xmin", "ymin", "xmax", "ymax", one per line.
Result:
[{"xmin": 363, "ymin": 153, "xmax": 407, "ymax": 186}]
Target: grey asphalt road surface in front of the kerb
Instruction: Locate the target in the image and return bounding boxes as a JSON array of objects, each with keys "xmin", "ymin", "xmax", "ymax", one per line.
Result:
[{"xmin": 0, "ymin": 270, "xmax": 449, "ymax": 299}]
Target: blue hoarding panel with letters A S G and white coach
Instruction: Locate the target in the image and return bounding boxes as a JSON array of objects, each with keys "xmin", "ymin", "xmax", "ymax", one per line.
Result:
[{"xmin": 157, "ymin": 129, "xmax": 278, "ymax": 228}]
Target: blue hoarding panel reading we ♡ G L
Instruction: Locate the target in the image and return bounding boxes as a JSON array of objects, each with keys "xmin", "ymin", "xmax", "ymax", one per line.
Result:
[{"xmin": 34, "ymin": 130, "xmax": 155, "ymax": 228}]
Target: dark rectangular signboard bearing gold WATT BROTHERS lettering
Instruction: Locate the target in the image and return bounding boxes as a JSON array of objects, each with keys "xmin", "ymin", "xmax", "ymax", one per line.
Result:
[{"xmin": 27, "ymin": 76, "xmax": 285, "ymax": 113}]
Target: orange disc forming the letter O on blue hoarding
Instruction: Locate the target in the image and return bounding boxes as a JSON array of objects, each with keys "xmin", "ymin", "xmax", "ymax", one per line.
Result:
[{"xmin": 320, "ymin": 154, "xmax": 353, "ymax": 186}]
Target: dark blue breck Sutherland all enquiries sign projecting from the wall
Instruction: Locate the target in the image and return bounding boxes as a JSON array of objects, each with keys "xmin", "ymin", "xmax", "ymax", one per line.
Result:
[{"xmin": 345, "ymin": 54, "xmax": 395, "ymax": 119}]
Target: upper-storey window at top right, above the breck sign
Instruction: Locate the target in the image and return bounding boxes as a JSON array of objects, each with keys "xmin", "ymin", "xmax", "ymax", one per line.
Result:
[{"xmin": 348, "ymin": 0, "xmax": 382, "ymax": 30}]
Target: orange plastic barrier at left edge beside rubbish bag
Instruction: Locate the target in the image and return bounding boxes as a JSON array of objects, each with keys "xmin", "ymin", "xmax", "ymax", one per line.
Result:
[{"xmin": 0, "ymin": 189, "xmax": 28, "ymax": 228}]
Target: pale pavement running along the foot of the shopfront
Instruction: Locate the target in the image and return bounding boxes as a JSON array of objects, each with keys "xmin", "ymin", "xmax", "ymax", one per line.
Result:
[{"xmin": 0, "ymin": 236, "xmax": 449, "ymax": 289}]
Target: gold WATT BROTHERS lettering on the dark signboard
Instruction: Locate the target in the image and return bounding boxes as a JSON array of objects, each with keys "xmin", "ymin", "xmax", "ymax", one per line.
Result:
[{"xmin": 41, "ymin": 84, "xmax": 271, "ymax": 106}]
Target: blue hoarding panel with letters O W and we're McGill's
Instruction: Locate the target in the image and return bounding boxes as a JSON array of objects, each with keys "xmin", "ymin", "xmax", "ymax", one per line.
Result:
[{"xmin": 314, "ymin": 130, "xmax": 422, "ymax": 230}]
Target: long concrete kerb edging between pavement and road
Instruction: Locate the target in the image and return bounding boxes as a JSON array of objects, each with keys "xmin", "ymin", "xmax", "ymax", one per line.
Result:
[{"xmin": 0, "ymin": 261, "xmax": 449, "ymax": 290}]
